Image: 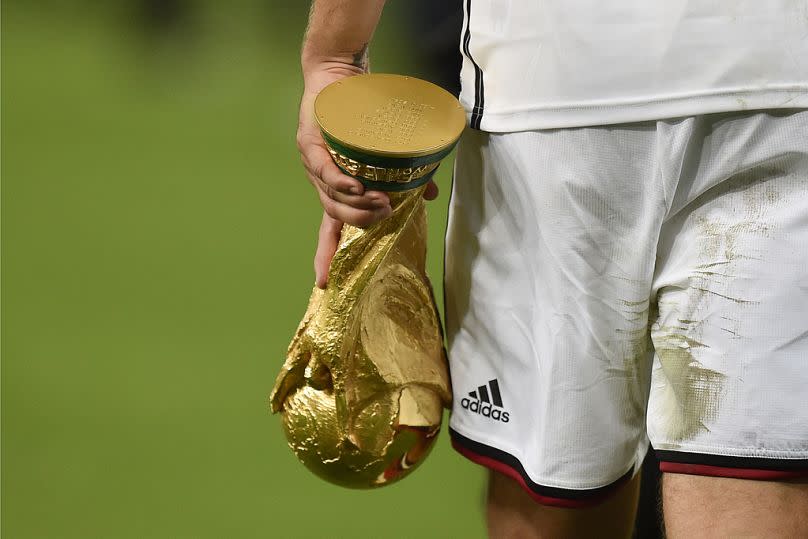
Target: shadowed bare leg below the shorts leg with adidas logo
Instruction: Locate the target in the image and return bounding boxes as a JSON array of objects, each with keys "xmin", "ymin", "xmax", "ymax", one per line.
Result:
[{"xmin": 486, "ymin": 472, "xmax": 640, "ymax": 539}]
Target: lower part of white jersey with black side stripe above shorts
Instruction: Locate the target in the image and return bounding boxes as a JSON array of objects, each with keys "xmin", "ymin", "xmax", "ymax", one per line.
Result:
[{"xmin": 461, "ymin": 0, "xmax": 808, "ymax": 132}]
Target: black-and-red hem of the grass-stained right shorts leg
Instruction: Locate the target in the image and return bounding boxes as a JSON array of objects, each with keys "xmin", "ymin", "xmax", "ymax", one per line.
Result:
[{"xmin": 656, "ymin": 451, "xmax": 808, "ymax": 481}]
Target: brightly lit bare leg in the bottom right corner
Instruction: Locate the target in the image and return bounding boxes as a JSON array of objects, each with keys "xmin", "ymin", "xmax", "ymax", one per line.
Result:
[{"xmin": 662, "ymin": 474, "xmax": 808, "ymax": 539}]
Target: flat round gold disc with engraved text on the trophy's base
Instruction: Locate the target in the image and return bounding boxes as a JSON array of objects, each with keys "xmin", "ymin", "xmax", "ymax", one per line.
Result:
[{"xmin": 314, "ymin": 73, "xmax": 466, "ymax": 158}]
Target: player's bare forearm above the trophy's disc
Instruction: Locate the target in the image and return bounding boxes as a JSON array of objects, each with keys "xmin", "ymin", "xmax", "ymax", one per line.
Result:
[{"xmin": 301, "ymin": 0, "xmax": 385, "ymax": 74}]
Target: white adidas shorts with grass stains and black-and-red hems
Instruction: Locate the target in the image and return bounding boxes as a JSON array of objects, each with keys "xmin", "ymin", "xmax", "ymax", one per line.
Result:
[{"xmin": 445, "ymin": 110, "xmax": 808, "ymax": 506}]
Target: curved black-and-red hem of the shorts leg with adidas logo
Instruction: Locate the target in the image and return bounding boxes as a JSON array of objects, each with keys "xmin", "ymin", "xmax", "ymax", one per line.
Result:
[{"xmin": 449, "ymin": 428, "xmax": 634, "ymax": 508}]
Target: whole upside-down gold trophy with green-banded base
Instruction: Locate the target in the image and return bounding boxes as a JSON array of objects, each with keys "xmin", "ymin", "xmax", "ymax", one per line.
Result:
[{"xmin": 270, "ymin": 74, "xmax": 465, "ymax": 488}]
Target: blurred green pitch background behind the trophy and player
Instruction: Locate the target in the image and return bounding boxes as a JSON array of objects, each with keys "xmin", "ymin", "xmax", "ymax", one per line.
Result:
[{"xmin": 2, "ymin": 0, "xmax": 484, "ymax": 539}]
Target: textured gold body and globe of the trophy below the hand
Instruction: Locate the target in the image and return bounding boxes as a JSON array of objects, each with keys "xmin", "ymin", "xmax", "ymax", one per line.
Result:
[{"xmin": 270, "ymin": 187, "xmax": 451, "ymax": 488}]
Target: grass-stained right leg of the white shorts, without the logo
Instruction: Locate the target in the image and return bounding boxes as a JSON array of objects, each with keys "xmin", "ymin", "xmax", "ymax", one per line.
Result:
[{"xmin": 648, "ymin": 108, "xmax": 808, "ymax": 479}]
